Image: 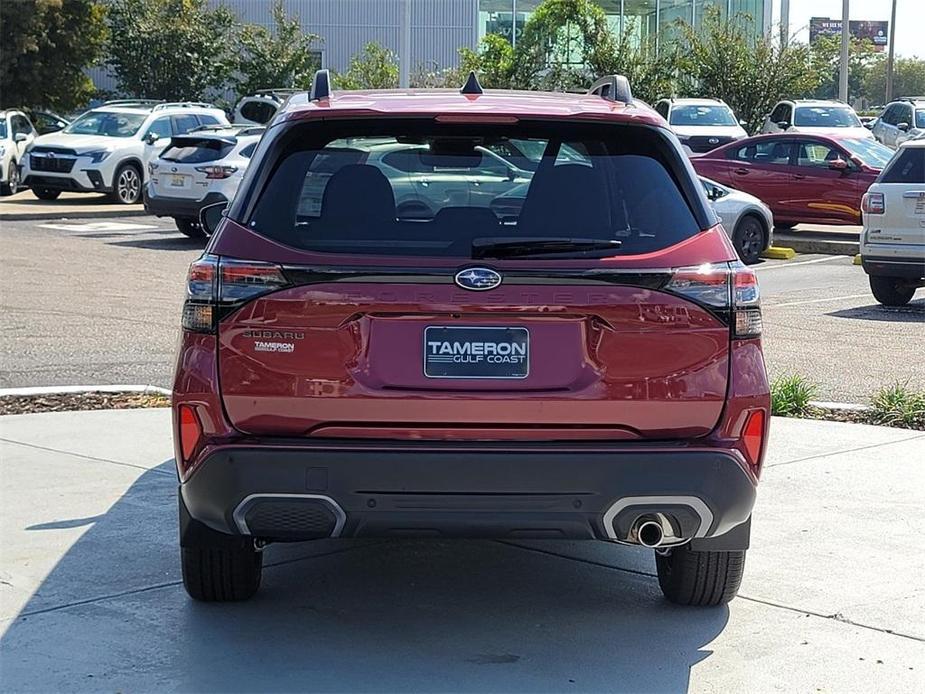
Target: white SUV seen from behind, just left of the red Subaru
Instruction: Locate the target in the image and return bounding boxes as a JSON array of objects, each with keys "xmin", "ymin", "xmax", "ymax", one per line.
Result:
[{"xmin": 144, "ymin": 125, "xmax": 264, "ymax": 238}]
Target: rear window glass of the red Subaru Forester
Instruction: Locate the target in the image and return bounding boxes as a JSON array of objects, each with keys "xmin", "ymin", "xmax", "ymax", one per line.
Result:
[{"xmin": 240, "ymin": 120, "xmax": 712, "ymax": 258}]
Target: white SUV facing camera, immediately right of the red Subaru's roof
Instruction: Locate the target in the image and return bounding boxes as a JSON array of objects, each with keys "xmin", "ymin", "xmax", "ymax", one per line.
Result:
[{"xmin": 655, "ymin": 99, "xmax": 748, "ymax": 154}]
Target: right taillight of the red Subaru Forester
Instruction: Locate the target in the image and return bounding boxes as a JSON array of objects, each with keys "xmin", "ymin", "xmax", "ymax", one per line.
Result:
[{"xmin": 664, "ymin": 261, "xmax": 761, "ymax": 339}]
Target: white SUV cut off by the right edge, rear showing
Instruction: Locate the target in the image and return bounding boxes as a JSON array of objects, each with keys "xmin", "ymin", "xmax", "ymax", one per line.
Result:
[{"xmin": 861, "ymin": 140, "xmax": 925, "ymax": 306}]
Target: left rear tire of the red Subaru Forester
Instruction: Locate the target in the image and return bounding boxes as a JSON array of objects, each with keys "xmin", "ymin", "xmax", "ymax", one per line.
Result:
[{"xmin": 180, "ymin": 547, "xmax": 263, "ymax": 602}]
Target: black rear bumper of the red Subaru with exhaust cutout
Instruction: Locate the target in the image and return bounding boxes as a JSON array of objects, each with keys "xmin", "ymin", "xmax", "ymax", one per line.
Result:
[{"xmin": 180, "ymin": 442, "xmax": 755, "ymax": 549}]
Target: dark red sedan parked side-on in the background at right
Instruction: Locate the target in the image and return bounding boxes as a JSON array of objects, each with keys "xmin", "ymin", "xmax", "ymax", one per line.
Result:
[{"xmin": 692, "ymin": 133, "xmax": 893, "ymax": 227}]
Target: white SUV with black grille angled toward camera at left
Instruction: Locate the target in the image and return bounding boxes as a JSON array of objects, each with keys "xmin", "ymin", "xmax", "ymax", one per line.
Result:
[{"xmin": 23, "ymin": 100, "xmax": 228, "ymax": 205}]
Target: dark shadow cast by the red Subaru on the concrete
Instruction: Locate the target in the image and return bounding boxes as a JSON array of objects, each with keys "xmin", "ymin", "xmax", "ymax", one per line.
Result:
[{"xmin": 0, "ymin": 461, "xmax": 729, "ymax": 692}]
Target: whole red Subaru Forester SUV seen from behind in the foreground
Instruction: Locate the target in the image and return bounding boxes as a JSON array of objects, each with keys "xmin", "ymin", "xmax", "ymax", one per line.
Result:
[{"xmin": 173, "ymin": 72, "xmax": 770, "ymax": 605}]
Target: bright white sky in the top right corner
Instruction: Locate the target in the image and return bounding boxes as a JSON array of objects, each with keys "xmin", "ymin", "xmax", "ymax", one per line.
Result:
[{"xmin": 772, "ymin": 0, "xmax": 925, "ymax": 59}]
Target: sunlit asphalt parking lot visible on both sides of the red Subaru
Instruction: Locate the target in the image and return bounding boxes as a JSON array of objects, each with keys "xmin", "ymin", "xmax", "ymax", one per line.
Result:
[{"xmin": 0, "ymin": 217, "xmax": 925, "ymax": 402}]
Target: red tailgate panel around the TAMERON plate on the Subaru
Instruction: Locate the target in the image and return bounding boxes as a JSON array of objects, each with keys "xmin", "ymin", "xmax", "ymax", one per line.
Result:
[{"xmin": 219, "ymin": 282, "xmax": 730, "ymax": 439}]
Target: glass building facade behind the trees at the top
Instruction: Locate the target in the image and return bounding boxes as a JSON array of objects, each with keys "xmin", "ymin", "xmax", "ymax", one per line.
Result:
[{"xmin": 478, "ymin": 0, "xmax": 771, "ymax": 50}]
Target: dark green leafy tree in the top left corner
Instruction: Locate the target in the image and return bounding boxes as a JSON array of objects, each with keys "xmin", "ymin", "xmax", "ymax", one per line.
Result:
[{"xmin": 0, "ymin": 0, "xmax": 106, "ymax": 110}]
